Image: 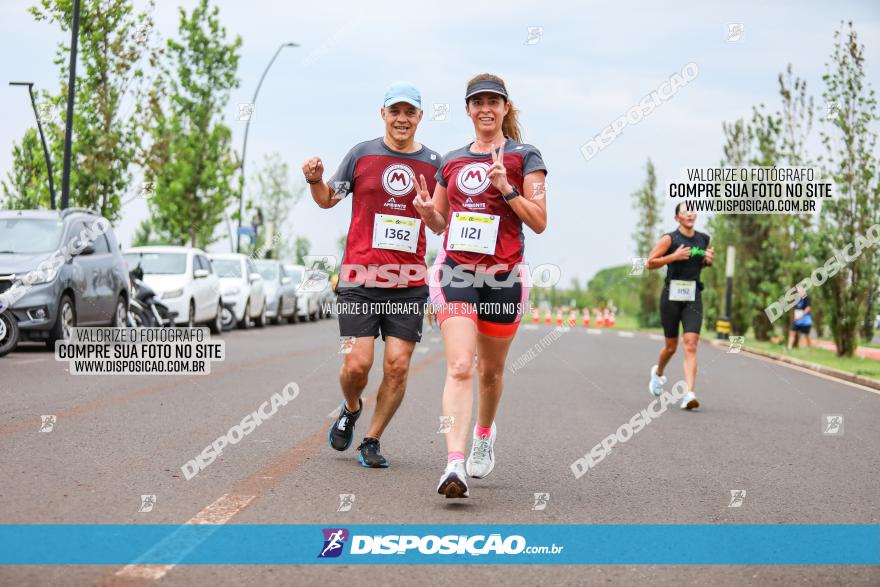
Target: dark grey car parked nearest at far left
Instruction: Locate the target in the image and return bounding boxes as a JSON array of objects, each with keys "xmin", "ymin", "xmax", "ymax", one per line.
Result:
[{"xmin": 0, "ymin": 208, "xmax": 130, "ymax": 347}]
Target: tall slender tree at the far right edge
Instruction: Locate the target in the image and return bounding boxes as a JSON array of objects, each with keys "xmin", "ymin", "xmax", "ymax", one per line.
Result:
[{"xmin": 820, "ymin": 22, "xmax": 880, "ymax": 356}]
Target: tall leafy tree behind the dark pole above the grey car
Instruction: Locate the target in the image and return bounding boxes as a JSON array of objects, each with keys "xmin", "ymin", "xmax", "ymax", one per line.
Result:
[{"xmin": 3, "ymin": 0, "xmax": 154, "ymax": 221}]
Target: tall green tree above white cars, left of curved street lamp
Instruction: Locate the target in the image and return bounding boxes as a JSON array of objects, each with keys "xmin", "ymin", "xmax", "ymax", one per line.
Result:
[{"xmin": 143, "ymin": 0, "xmax": 241, "ymax": 247}]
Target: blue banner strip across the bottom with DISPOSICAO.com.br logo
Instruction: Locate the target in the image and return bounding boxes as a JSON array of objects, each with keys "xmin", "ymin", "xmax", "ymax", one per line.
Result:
[{"xmin": 0, "ymin": 524, "xmax": 880, "ymax": 565}]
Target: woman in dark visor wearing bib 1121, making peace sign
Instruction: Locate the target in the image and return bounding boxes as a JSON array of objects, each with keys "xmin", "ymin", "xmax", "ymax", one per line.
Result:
[{"xmin": 414, "ymin": 74, "xmax": 547, "ymax": 497}]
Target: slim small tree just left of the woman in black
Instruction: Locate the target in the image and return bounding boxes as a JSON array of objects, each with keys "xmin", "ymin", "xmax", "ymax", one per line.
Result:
[{"xmin": 632, "ymin": 159, "xmax": 661, "ymax": 327}]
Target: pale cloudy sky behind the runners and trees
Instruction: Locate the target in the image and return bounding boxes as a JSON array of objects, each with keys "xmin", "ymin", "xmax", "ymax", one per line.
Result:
[{"xmin": 0, "ymin": 0, "xmax": 880, "ymax": 285}]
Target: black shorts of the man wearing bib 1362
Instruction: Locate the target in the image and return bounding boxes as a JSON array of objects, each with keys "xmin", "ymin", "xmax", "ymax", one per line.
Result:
[{"xmin": 336, "ymin": 285, "xmax": 428, "ymax": 342}]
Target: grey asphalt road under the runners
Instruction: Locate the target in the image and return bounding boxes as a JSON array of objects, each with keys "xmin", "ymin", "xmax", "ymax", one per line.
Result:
[{"xmin": 0, "ymin": 320, "xmax": 880, "ymax": 586}]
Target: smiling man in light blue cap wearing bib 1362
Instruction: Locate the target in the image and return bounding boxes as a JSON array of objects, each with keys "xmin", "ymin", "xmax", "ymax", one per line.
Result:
[{"xmin": 303, "ymin": 82, "xmax": 440, "ymax": 467}]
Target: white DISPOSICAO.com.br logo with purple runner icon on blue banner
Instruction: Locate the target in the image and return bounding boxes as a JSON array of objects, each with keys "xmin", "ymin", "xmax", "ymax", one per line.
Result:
[{"xmin": 318, "ymin": 528, "xmax": 565, "ymax": 558}]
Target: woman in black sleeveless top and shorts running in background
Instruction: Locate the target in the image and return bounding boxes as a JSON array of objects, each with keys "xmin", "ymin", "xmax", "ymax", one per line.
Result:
[{"xmin": 648, "ymin": 202, "xmax": 715, "ymax": 410}]
